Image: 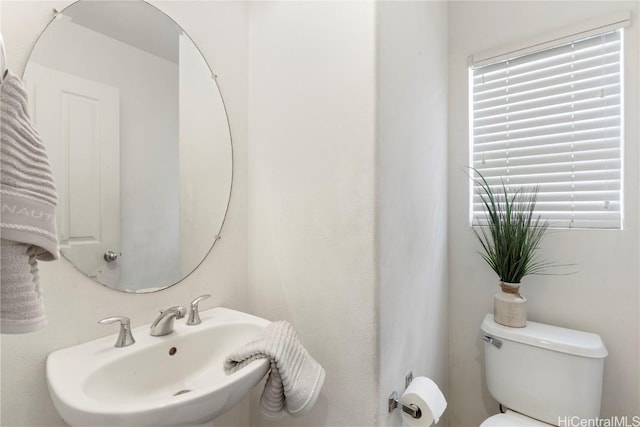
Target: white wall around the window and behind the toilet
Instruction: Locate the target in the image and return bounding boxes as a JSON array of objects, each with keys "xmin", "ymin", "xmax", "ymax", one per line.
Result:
[{"xmin": 448, "ymin": 1, "xmax": 640, "ymax": 427}]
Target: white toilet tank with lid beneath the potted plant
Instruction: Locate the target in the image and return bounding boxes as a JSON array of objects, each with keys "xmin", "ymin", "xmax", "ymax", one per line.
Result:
[{"xmin": 481, "ymin": 314, "xmax": 607, "ymax": 426}]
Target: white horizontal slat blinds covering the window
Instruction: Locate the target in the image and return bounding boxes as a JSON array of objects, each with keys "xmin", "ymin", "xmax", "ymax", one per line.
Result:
[{"xmin": 470, "ymin": 30, "xmax": 622, "ymax": 228}]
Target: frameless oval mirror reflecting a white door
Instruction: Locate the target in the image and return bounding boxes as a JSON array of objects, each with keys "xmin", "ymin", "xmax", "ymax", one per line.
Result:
[{"xmin": 24, "ymin": 0, "xmax": 232, "ymax": 292}]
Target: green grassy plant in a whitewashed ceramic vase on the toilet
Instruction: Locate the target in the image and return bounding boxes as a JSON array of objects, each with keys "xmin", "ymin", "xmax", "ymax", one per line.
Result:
[{"xmin": 473, "ymin": 169, "xmax": 549, "ymax": 327}]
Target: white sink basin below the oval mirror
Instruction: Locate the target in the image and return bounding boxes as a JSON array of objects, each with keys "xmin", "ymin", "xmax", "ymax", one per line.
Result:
[{"xmin": 47, "ymin": 308, "xmax": 269, "ymax": 426}]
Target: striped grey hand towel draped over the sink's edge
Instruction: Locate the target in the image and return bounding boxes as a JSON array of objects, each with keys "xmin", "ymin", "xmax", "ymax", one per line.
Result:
[{"xmin": 224, "ymin": 321, "xmax": 325, "ymax": 418}]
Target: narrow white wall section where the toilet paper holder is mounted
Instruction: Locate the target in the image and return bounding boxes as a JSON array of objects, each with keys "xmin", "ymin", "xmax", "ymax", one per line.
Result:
[{"xmin": 376, "ymin": 1, "xmax": 448, "ymax": 425}]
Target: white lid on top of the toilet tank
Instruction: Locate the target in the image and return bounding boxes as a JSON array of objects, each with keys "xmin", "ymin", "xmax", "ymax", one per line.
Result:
[{"xmin": 481, "ymin": 313, "xmax": 608, "ymax": 358}]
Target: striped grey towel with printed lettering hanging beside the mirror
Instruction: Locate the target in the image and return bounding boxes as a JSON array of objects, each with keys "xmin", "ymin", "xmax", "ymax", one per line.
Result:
[{"xmin": 0, "ymin": 73, "xmax": 59, "ymax": 334}]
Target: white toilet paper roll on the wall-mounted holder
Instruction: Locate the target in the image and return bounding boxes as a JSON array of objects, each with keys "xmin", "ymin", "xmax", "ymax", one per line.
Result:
[{"xmin": 398, "ymin": 377, "xmax": 447, "ymax": 427}]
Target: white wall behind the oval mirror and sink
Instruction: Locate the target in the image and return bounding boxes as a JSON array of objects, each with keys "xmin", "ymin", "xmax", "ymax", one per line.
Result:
[{"xmin": 0, "ymin": 0, "xmax": 249, "ymax": 427}]
